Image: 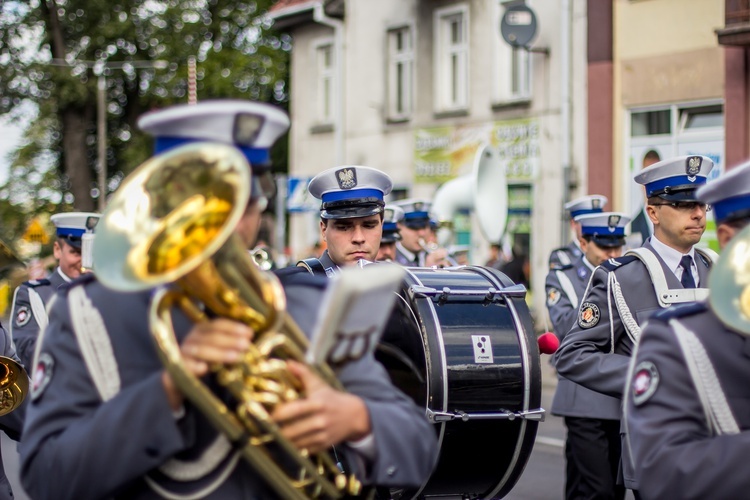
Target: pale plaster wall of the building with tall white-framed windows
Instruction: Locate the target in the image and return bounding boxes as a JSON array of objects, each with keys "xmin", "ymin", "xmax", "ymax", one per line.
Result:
[{"xmin": 282, "ymin": 0, "xmax": 588, "ymax": 322}]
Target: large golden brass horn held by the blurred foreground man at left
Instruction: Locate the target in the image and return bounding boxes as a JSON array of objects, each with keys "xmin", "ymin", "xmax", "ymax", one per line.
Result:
[{"xmin": 94, "ymin": 143, "xmax": 361, "ymax": 498}]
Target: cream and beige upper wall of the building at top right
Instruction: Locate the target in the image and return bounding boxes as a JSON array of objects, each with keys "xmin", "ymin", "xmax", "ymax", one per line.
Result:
[{"xmin": 614, "ymin": 0, "xmax": 724, "ymax": 209}]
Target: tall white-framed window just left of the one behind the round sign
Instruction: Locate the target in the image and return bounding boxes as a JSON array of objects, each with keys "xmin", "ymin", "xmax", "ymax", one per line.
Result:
[{"xmin": 434, "ymin": 4, "xmax": 469, "ymax": 112}]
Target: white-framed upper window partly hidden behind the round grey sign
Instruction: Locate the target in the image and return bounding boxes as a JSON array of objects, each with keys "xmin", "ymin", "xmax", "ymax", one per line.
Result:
[{"xmin": 492, "ymin": 0, "xmax": 531, "ymax": 104}]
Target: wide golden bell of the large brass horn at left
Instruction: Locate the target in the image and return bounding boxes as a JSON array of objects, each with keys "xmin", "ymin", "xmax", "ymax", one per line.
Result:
[{"xmin": 93, "ymin": 142, "xmax": 250, "ymax": 291}]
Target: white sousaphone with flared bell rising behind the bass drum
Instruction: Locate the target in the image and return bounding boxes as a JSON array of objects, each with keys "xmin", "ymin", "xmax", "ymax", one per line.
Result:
[{"xmin": 432, "ymin": 144, "xmax": 508, "ymax": 246}]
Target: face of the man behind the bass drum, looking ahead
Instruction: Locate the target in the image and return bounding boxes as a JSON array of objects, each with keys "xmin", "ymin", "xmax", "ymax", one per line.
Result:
[{"xmin": 320, "ymin": 214, "xmax": 383, "ymax": 267}]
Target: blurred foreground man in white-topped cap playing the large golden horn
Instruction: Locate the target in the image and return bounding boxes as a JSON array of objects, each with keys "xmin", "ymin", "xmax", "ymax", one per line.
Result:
[{"xmin": 20, "ymin": 100, "xmax": 437, "ymax": 499}]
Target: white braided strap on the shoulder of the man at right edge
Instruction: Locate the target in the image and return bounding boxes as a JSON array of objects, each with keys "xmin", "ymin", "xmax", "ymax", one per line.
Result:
[{"xmin": 669, "ymin": 319, "xmax": 740, "ymax": 435}]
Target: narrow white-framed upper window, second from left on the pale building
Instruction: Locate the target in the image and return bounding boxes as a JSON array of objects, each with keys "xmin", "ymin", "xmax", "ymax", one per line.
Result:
[{"xmin": 388, "ymin": 26, "xmax": 414, "ymax": 120}]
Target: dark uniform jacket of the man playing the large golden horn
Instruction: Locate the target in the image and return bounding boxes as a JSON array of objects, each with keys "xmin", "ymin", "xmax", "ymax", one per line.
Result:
[{"xmin": 20, "ymin": 274, "xmax": 437, "ymax": 500}]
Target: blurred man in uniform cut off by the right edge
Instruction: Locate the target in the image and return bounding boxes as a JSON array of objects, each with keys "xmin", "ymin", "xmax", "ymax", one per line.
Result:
[{"xmin": 624, "ymin": 163, "xmax": 750, "ymax": 499}]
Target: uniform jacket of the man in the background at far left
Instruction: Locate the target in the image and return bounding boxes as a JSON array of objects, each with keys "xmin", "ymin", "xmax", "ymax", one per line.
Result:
[{"xmin": 10, "ymin": 267, "xmax": 69, "ymax": 370}]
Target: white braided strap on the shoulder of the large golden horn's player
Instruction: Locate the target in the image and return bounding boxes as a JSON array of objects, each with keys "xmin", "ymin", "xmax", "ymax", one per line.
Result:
[{"xmin": 68, "ymin": 286, "xmax": 120, "ymax": 401}]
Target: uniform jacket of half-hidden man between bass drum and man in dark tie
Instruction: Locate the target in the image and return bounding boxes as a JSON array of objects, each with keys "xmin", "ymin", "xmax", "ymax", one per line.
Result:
[{"xmin": 545, "ymin": 255, "xmax": 620, "ymax": 420}]
